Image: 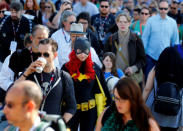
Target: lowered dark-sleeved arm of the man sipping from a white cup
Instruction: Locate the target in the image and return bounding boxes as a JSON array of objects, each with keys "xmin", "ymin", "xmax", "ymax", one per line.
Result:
[{"xmin": 61, "ymin": 71, "xmax": 76, "ymax": 122}]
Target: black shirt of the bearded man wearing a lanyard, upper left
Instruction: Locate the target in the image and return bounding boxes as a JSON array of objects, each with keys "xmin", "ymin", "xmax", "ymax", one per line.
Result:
[{"xmin": 0, "ymin": 16, "xmax": 33, "ymax": 62}]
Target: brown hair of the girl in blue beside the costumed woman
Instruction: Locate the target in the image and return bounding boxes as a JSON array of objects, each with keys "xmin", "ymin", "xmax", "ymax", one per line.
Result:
[{"xmin": 102, "ymin": 52, "xmax": 118, "ymax": 77}]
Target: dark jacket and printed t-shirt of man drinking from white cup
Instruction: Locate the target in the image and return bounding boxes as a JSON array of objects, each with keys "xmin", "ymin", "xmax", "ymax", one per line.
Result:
[{"xmin": 27, "ymin": 69, "xmax": 76, "ymax": 115}]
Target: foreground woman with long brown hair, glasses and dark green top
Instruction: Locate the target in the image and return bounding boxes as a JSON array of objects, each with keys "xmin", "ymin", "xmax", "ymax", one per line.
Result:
[{"xmin": 96, "ymin": 77, "xmax": 160, "ymax": 131}]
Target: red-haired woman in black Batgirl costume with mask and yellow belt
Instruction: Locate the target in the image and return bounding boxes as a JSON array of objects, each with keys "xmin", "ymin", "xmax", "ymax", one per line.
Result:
[{"xmin": 62, "ymin": 37, "xmax": 111, "ymax": 131}]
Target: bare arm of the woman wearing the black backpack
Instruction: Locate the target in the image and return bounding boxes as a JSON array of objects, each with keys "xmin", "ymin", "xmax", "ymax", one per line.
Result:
[{"xmin": 142, "ymin": 68, "xmax": 155, "ymax": 101}]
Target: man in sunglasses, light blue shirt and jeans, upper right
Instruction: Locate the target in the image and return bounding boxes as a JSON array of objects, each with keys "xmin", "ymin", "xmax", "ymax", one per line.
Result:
[{"xmin": 142, "ymin": 0, "xmax": 179, "ymax": 80}]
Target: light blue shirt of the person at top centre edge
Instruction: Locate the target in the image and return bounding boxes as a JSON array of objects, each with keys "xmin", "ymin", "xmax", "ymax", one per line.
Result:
[{"xmin": 73, "ymin": 1, "xmax": 99, "ymax": 16}]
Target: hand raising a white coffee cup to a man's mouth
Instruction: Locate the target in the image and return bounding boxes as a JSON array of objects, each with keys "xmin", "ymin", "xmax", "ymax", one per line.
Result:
[{"xmin": 24, "ymin": 60, "xmax": 44, "ymax": 76}]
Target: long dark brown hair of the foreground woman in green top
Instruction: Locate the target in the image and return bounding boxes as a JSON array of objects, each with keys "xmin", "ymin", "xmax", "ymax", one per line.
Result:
[{"xmin": 114, "ymin": 77, "xmax": 153, "ymax": 131}]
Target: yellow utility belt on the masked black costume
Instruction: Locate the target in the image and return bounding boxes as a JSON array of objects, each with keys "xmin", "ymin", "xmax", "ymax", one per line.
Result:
[{"xmin": 77, "ymin": 99, "xmax": 96, "ymax": 111}]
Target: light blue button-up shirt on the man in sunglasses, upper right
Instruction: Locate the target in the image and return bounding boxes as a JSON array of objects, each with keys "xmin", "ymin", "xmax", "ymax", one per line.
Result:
[{"xmin": 142, "ymin": 14, "xmax": 179, "ymax": 60}]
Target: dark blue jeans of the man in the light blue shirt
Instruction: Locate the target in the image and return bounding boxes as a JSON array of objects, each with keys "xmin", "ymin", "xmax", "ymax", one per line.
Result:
[{"xmin": 145, "ymin": 55, "xmax": 157, "ymax": 82}]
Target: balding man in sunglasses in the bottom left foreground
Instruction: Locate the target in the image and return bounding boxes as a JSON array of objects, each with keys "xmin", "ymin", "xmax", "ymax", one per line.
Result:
[{"xmin": 3, "ymin": 81, "xmax": 54, "ymax": 131}]
